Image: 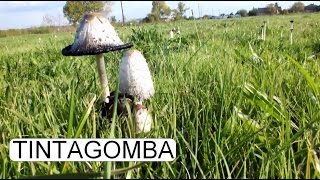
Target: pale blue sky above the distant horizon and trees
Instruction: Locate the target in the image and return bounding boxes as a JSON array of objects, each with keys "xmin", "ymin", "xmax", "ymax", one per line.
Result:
[{"xmin": 0, "ymin": 1, "xmax": 320, "ymax": 30}]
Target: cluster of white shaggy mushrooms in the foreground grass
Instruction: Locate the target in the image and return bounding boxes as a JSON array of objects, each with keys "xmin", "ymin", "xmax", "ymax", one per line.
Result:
[{"xmin": 62, "ymin": 12, "xmax": 155, "ymax": 133}]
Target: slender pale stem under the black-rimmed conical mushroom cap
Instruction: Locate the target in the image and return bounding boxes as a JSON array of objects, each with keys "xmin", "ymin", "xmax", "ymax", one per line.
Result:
[{"xmin": 96, "ymin": 53, "xmax": 110, "ymax": 103}]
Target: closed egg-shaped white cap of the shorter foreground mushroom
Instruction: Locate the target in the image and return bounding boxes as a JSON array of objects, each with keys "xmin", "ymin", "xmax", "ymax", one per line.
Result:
[{"xmin": 119, "ymin": 50, "xmax": 155, "ymax": 101}]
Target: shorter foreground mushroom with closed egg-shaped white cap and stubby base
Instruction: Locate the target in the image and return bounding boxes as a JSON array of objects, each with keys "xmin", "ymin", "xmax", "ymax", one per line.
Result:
[{"xmin": 119, "ymin": 50, "xmax": 155, "ymax": 133}]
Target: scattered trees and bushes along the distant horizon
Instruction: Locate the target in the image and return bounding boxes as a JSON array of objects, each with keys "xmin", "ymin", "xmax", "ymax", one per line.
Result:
[{"xmin": 57, "ymin": 1, "xmax": 320, "ymax": 26}]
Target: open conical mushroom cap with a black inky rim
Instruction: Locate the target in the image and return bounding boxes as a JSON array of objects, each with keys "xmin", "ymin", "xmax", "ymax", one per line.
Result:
[{"xmin": 62, "ymin": 13, "xmax": 133, "ymax": 56}]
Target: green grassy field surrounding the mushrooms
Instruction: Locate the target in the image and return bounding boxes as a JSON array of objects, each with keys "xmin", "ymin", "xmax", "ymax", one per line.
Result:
[{"xmin": 0, "ymin": 14, "xmax": 320, "ymax": 178}]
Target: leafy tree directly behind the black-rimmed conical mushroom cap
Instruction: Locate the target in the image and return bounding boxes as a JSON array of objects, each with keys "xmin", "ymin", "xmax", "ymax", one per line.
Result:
[{"xmin": 63, "ymin": 1, "xmax": 112, "ymax": 26}]
